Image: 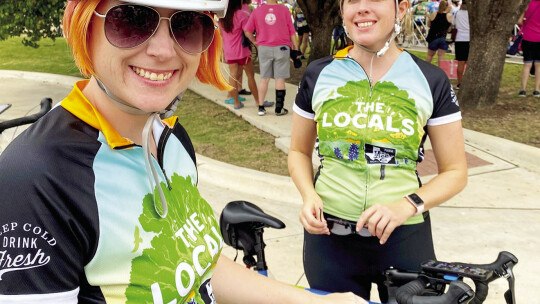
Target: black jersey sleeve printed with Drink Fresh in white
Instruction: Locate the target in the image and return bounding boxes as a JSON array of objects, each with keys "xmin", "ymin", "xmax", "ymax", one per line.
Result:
[{"xmin": 0, "ymin": 107, "xmax": 99, "ymax": 297}]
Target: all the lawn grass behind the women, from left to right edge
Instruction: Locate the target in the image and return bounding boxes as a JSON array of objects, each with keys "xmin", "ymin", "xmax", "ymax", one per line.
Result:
[{"xmin": 0, "ymin": 38, "xmax": 540, "ymax": 175}]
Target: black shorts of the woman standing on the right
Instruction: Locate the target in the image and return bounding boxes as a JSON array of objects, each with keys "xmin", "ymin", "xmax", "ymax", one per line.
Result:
[{"xmin": 304, "ymin": 212, "xmax": 435, "ymax": 302}]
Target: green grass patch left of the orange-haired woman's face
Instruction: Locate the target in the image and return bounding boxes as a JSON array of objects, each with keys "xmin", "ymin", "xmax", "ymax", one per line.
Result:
[{"xmin": 0, "ymin": 37, "xmax": 81, "ymax": 77}]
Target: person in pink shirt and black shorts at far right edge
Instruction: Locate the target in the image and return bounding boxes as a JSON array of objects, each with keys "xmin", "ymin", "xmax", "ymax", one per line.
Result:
[{"xmin": 518, "ymin": 0, "xmax": 540, "ymax": 98}]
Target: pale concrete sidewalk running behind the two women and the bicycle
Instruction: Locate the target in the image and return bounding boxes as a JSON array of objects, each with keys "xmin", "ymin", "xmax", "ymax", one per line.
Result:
[{"xmin": 0, "ymin": 70, "xmax": 540, "ymax": 303}]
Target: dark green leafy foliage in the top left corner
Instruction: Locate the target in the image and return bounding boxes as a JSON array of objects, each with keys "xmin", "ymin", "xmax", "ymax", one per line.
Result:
[{"xmin": 0, "ymin": 0, "xmax": 65, "ymax": 48}]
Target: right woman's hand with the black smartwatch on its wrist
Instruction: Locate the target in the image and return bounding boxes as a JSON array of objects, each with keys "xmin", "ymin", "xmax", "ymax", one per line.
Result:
[{"xmin": 356, "ymin": 198, "xmax": 416, "ymax": 245}]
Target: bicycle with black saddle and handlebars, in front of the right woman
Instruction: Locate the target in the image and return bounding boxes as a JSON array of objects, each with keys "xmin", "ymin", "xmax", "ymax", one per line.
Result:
[{"xmin": 220, "ymin": 201, "xmax": 518, "ymax": 304}]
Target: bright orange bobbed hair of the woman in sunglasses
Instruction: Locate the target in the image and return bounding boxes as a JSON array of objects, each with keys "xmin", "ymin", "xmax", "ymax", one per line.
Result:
[{"xmin": 62, "ymin": 0, "xmax": 232, "ymax": 90}]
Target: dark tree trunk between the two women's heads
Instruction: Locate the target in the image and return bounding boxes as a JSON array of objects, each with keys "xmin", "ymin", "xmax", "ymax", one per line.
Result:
[{"xmin": 297, "ymin": 0, "xmax": 341, "ymax": 63}]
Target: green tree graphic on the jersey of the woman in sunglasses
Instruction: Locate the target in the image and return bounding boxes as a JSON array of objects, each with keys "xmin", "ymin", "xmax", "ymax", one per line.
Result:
[{"xmin": 126, "ymin": 175, "xmax": 221, "ymax": 303}]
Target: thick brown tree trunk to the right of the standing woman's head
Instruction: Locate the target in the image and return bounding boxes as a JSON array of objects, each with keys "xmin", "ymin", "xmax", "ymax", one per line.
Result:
[{"xmin": 458, "ymin": 0, "xmax": 531, "ymax": 109}]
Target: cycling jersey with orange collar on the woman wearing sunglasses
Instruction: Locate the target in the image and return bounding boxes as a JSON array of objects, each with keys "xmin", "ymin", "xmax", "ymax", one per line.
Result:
[{"xmin": 0, "ymin": 80, "xmax": 223, "ymax": 304}]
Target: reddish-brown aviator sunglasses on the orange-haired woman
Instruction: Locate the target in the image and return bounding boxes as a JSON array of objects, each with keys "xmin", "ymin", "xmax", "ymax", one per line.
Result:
[{"xmin": 94, "ymin": 4, "xmax": 217, "ymax": 54}]
